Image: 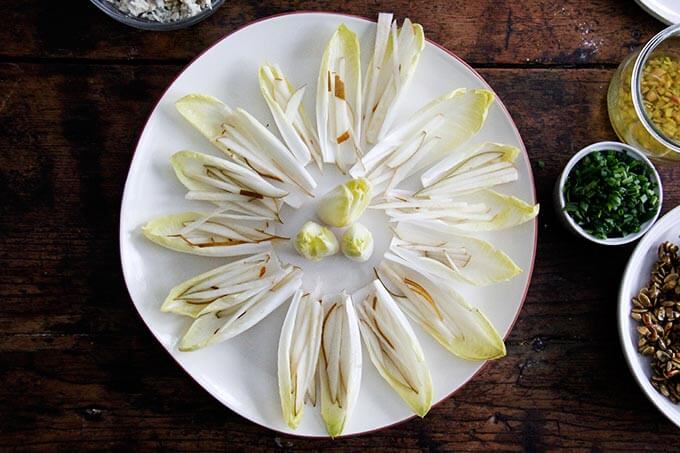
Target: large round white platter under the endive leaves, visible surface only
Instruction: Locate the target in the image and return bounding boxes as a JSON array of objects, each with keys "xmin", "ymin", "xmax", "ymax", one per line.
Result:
[{"xmin": 120, "ymin": 13, "xmax": 537, "ymax": 436}]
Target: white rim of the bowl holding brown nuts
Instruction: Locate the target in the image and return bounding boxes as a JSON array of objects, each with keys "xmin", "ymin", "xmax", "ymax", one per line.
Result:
[{"xmin": 617, "ymin": 206, "xmax": 680, "ymax": 428}]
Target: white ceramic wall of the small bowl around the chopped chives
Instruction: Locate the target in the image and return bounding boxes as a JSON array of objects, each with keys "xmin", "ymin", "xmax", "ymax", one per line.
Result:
[{"xmin": 553, "ymin": 142, "xmax": 663, "ymax": 245}]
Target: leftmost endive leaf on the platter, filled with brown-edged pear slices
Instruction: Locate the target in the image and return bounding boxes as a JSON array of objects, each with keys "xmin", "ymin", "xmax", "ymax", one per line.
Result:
[{"xmin": 142, "ymin": 212, "xmax": 283, "ymax": 257}]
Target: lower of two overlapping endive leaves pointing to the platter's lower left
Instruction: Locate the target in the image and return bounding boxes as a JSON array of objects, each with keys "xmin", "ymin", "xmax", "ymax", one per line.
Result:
[{"xmin": 179, "ymin": 266, "xmax": 302, "ymax": 351}]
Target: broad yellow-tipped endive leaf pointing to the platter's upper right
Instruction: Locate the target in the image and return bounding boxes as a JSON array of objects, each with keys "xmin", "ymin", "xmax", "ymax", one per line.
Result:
[{"xmin": 350, "ymin": 88, "xmax": 494, "ymax": 193}]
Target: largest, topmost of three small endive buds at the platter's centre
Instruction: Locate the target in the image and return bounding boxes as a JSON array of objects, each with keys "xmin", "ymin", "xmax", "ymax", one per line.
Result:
[{"xmin": 317, "ymin": 178, "xmax": 373, "ymax": 227}]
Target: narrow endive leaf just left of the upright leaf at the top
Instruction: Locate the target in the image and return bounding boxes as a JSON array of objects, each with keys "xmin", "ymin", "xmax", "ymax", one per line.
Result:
[{"xmin": 258, "ymin": 64, "xmax": 323, "ymax": 169}]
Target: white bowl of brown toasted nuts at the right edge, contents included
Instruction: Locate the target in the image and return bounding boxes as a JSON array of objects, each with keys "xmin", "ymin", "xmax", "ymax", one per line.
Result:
[{"xmin": 617, "ymin": 207, "xmax": 680, "ymax": 427}]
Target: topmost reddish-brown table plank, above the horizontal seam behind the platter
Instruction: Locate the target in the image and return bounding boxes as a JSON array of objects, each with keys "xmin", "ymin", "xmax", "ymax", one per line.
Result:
[{"xmin": 0, "ymin": 0, "xmax": 662, "ymax": 65}]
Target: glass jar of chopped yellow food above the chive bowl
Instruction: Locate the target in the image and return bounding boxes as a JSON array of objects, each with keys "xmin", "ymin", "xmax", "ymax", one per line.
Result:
[{"xmin": 607, "ymin": 24, "xmax": 680, "ymax": 161}]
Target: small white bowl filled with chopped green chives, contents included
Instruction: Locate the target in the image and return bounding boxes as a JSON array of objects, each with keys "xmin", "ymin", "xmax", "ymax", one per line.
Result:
[{"xmin": 554, "ymin": 142, "xmax": 663, "ymax": 245}]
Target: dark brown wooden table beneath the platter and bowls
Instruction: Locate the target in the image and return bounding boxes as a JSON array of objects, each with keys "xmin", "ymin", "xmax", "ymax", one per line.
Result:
[{"xmin": 0, "ymin": 0, "xmax": 680, "ymax": 451}]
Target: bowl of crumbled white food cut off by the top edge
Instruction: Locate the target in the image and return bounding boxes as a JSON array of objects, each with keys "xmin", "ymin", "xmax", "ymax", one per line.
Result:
[{"xmin": 91, "ymin": 0, "xmax": 224, "ymax": 31}]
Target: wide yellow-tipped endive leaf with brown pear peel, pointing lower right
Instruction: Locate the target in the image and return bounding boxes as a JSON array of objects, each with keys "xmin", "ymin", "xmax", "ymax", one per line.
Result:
[{"xmin": 378, "ymin": 258, "xmax": 506, "ymax": 360}]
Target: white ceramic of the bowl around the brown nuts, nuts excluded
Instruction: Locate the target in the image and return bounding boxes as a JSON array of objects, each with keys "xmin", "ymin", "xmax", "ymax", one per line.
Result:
[{"xmin": 617, "ymin": 206, "xmax": 680, "ymax": 427}]
